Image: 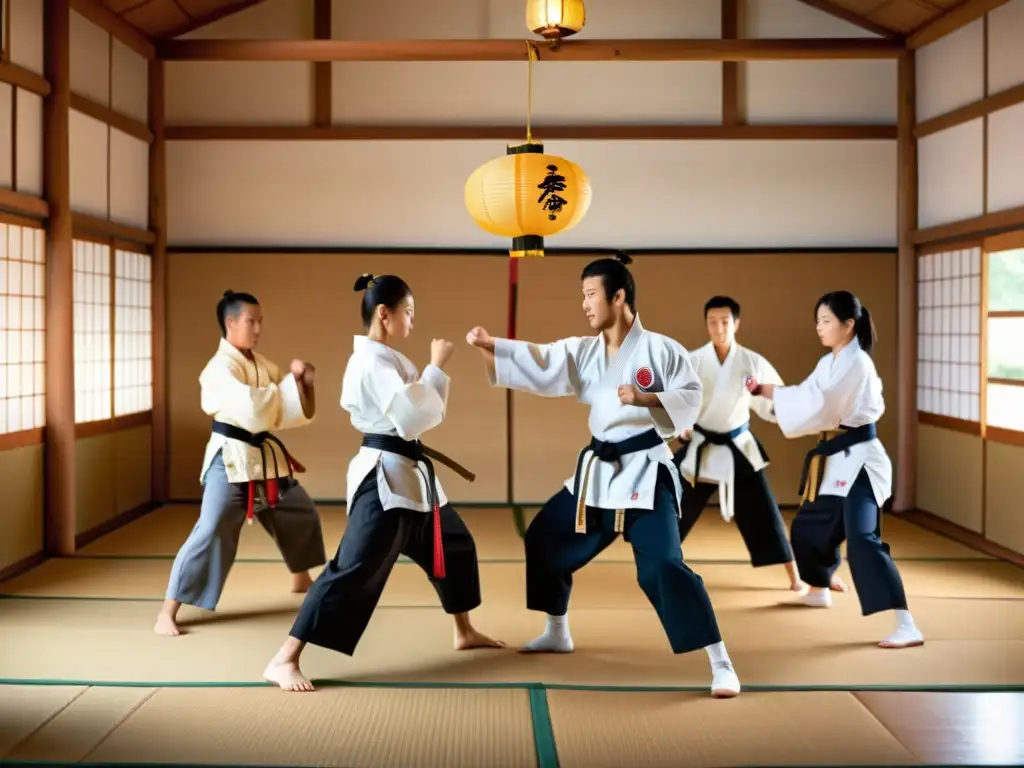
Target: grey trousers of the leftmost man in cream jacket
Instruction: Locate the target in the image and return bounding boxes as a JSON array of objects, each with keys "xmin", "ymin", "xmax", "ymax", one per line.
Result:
[{"xmin": 167, "ymin": 454, "xmax": 327, "ymax": 610}]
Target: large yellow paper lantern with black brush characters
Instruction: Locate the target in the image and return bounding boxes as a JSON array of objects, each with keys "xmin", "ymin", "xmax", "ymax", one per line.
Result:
[{"xmin": 466, "ymin": 142, "xmax": 591, "ymax": 258}]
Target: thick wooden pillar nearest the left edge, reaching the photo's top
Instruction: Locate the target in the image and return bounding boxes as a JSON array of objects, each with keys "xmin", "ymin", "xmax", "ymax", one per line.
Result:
[{"xmin": 41, "ymin": 0, "xmax": 77, "ymax": 556}]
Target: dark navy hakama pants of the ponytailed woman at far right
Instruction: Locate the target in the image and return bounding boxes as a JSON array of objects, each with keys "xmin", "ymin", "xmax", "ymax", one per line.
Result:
[{"xmin": 791, "ymin": 469, "xmax": 907, "ymax": 616}]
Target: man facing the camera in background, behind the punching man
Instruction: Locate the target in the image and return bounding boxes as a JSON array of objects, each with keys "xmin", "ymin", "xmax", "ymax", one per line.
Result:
[{"xmin": 675, "ymin": 296, "xmax": 807, "ymax": 592}]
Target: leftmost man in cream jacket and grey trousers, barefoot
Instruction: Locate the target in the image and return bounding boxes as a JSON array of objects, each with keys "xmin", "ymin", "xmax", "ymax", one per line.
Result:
[{"xmin": 156, "ymin": 291, "xmax": 327, "ymax": 636}]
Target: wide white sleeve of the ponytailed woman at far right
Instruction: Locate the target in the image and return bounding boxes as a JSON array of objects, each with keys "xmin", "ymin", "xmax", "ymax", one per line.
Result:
[{"xmin": 772, "ymin": 357, "xmax": 869, "ymax": 438}]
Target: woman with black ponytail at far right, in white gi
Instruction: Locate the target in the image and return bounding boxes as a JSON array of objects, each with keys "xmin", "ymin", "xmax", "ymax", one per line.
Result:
[{"xmin": 748, "ymin": 291, "xmax": 925, "ymax": 648}]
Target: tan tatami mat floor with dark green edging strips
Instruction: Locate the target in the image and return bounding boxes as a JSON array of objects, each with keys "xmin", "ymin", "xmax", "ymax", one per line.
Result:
[{"xmin": 0, "ymin": 505, "xmax": 1024, "ymax": 768}]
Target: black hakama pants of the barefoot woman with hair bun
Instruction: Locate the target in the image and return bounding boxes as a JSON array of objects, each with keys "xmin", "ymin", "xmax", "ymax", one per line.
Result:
[{"xmin": 290, "ymin": 470, "xmax": 480, "ymax": 655}]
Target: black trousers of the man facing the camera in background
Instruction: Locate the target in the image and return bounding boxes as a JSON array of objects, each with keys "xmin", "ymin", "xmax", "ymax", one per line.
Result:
[{"xmin": 679, "ymin": 462, "xmax": 793, "ymax": 568}]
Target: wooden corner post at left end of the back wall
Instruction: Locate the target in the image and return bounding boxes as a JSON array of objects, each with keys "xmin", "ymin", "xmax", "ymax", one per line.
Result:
[{"xmin": 148, "ymin": 58, "xmax": 170, "ymax": 504}]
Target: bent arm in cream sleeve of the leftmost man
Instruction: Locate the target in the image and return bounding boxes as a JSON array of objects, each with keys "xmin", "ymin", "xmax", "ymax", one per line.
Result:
[{"xmin": 199, "ymin": 359, "xmax": 309, "ymax": 433}]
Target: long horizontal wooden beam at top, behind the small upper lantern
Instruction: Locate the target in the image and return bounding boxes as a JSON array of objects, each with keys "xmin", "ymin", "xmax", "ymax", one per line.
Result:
[{"xmin": 157, "ymin": 38, "xmax": 904, "ymax": 61}]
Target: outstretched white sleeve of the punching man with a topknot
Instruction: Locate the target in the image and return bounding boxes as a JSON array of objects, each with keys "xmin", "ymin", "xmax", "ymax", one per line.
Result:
[{"xmin": 490, "ymin": 337, "xmax": 583, "ymax": 397}]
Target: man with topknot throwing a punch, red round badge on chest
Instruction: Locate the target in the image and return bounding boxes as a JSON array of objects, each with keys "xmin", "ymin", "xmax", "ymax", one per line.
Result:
[{"xmin": 467, "ymin": 254, "xmax": 739, "ymax": 696}]
